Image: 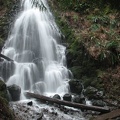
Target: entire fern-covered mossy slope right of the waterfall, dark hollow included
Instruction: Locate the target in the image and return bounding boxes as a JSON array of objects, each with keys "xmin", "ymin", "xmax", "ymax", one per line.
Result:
[{"xmin": 51, "ymin": 0, "xmax": 120, "ymax": 99}]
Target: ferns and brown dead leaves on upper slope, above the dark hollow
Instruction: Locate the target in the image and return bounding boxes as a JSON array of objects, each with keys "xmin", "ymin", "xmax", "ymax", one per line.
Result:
[{"xmin": 54, "ymin": 0, "xmax": 120, "ymax": 66}]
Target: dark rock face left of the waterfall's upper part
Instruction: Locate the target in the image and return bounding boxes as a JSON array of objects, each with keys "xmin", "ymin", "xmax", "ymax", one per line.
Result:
[{"xmin": 0, "ymin": 0, "xmax": 20, "ymax": 51}]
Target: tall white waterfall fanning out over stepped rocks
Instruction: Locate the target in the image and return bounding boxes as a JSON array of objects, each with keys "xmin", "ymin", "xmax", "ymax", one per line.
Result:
[{"xmin": 2, "ymin": 0, "xmax": 69, "ymax": 98}]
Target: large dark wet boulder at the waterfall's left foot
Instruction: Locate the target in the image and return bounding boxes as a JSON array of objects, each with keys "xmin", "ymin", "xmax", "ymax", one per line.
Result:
[{"xmin": 8, "ymin": 84, "xmax": 21, "ymax": 101}]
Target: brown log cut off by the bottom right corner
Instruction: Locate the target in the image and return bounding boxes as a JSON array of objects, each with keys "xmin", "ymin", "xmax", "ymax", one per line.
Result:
[{"xmin": 94, "ymin": 109, "xmax": 120, "ymax": 120}]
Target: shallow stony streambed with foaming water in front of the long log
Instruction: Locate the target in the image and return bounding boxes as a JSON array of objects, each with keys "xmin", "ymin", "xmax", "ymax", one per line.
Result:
[{"xmin": 10, "ymin": 100, "xmax": 87, "ymax": 120}]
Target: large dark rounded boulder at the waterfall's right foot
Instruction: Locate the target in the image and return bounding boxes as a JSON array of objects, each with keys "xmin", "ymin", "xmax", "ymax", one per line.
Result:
[{"xmin": 69, "ymin": 79, "xmax": 83, "ymax": 94}]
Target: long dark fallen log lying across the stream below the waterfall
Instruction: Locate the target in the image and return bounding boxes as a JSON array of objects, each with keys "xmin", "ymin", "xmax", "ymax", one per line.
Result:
[{"xmin": 25, "ymin": 92, "xmax": 109, "ymax": 113}]
